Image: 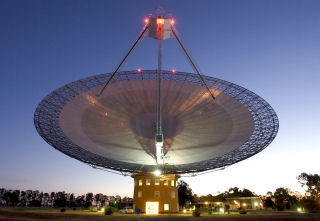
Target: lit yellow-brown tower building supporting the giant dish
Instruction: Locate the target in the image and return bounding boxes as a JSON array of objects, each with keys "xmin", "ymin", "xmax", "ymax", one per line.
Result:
[{"xmin": 131, "ymin": 174, "xmax": 180, "ymax": 214}]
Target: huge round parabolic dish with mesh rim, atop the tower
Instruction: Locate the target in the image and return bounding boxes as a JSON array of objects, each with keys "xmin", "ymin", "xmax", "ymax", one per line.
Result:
[{"xmin": 34, "ymin": 70, "xmax": 279, "ymax": 174}]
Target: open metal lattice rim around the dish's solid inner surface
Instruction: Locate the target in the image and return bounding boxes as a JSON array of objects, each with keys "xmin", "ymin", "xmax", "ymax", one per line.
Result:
[{"xmin": 34, "ymin": 70, "xmax": 279, "ymax": 174}]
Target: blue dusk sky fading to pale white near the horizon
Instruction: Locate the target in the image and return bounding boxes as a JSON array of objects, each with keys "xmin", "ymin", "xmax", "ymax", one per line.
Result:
[{"xmin": 0, "ymin": 0, "xmax": 320, "ymax": 197}]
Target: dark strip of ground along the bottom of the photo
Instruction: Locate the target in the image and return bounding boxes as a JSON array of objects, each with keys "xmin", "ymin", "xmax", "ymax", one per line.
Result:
[{"xmin": 0, "ymin": 207, "xmax": 320, "ymax": 221}]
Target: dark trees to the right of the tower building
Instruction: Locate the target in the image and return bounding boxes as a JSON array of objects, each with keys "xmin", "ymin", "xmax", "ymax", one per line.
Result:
[{"xmin": 178, "ymin": 173, "xmax": 320, "ymax": 212}]
